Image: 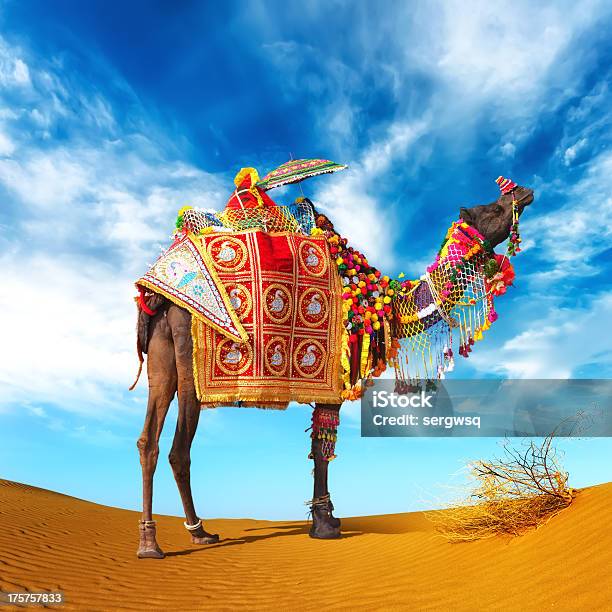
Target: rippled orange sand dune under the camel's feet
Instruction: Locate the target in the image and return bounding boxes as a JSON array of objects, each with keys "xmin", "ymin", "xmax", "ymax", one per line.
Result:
[{"xmin": 0, "ymin": 480, "xmax": 612, "ymax": 612}]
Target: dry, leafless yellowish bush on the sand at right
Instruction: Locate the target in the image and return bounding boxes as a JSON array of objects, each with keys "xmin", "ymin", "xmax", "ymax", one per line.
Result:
[{"xmin": 427, "ymin": 432, "xmax": 576, "ymax": 542}]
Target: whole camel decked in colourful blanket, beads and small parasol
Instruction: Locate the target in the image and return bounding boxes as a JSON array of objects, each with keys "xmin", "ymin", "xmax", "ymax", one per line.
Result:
[{"xmin": 132, "ymin": 160, "xmax": 533, "ymax": 558}]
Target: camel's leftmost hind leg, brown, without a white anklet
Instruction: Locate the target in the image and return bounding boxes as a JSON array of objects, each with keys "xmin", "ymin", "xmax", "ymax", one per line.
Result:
[{"xmin": 137, "ymin": 312, "xmax": 177, "ymax": 559}]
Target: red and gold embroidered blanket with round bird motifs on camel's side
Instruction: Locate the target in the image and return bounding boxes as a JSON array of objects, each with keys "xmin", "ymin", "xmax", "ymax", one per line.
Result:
[{"xmin": 138, "ymin": 230, "xmax": 344, "ymax": 408}]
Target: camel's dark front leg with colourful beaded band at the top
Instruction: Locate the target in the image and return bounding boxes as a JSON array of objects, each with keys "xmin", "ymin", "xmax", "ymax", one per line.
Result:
[{"xmin": 310, "ymin": 404, "xmax": 340, "ymax": 539}]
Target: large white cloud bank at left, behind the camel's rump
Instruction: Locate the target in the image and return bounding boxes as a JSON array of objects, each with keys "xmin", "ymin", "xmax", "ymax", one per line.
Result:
[{"xmin": 0, "ymin": 39, "xmax": 230, "ymax": 418}]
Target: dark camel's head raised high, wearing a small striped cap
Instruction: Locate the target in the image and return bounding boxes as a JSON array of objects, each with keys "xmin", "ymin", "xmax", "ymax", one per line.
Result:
[{"xmin": 459, "ymin": 177, "xmax": 533, "ymax": 248}]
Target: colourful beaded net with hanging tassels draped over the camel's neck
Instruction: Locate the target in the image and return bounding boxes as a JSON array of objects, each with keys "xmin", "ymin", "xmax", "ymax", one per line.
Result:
[{"xmin": 392, "ymin": 182, "xmax": 521, "ymax": 389}]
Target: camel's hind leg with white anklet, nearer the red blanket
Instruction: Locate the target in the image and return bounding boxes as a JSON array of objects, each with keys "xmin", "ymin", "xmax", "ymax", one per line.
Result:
[{"xmin": 168, "ymin": 306, "xmax": 219, "ymax": 544}]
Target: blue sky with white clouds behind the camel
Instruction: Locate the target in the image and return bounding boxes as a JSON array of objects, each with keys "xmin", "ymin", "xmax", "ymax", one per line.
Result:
[{"xmin": 0, "ymin": 1, "xmax": 612, "ymax": 518}]
